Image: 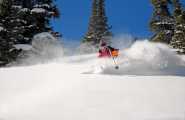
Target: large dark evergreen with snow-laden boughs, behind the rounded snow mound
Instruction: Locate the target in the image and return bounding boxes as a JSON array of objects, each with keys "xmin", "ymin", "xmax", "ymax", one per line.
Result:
[{"xmin": 0, "ymin": 0, "xmax": 59, "ymax": 44}]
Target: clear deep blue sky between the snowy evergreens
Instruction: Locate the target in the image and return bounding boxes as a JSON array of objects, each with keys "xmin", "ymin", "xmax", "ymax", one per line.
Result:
[{"xmin": 51, "ymin": 0, "xmax": 185, "ymax": 40}]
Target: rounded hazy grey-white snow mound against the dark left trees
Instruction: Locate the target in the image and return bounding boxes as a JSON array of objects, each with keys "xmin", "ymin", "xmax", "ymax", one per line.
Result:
[{"xmin": 15, "ymin": 32, "xmax": 64, "ymax": 65}]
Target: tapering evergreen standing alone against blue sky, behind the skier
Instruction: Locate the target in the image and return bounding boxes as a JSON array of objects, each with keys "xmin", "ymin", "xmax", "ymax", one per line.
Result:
[{"xmin": 83, "ymin": 0, "xmax": 112, "ymax": 45}]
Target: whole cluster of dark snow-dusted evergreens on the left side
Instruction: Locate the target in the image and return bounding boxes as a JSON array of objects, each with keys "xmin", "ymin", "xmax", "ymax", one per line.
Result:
[{"xmin": 0, "ymin": 0, "xmax": 59, "ymax": 63}]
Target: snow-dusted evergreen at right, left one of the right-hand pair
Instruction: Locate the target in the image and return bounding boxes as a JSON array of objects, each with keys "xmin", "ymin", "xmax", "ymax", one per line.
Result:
[{"xmin": 150, "ymin": 0, "xmax": 174, "ymax": 44}]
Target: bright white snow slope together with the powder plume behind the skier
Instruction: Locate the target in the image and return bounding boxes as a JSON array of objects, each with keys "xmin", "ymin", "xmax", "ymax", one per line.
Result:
[{"xmin": 0, "ymin": 38, "xmax": 185, "ymax": 120}]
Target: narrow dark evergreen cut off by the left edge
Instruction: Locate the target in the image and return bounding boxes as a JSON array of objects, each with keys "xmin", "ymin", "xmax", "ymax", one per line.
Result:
[{"xmin": 0, "ymin": 0, "xmax": 20, "ymax": 67}]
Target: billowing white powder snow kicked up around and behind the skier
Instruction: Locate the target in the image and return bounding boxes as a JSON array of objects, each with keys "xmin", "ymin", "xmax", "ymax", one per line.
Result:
[{"xmin": 88, "ymin": 41, "xmax": 185, "ymax": 76}]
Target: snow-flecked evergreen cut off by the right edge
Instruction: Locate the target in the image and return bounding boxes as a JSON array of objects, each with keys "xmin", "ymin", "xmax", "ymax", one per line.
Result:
[{"xmin": 170, "ymin": 0, "xmax": 185, "ymax": 54}]
